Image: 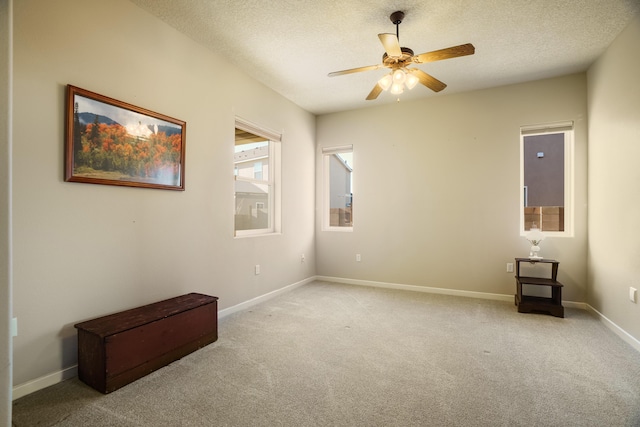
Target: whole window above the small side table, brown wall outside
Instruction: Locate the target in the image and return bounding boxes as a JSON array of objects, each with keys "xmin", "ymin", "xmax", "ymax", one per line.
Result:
[{"xmin": 520, "ymin": 122, "xmax": 573, "ymax": 236}]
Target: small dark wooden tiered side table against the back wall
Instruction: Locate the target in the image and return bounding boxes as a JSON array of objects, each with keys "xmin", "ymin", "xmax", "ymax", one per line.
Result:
[{"xmin": 515, "ymin": 258, "xmax": 564, "ymax": 317}]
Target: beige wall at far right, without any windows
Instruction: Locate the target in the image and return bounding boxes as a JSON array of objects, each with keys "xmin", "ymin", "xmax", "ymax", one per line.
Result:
[{"xmin": 588, "ymin": 17, "xmax": 640, "ymax": 340}]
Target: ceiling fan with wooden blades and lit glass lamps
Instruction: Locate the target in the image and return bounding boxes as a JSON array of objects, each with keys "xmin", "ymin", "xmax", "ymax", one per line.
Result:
[{"xmin": 329, "ymin": 11, "xmax": 476, "ymax": 101}]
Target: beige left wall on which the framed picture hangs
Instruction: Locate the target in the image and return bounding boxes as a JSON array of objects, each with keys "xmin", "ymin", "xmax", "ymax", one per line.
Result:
[{"xmin": 13, "ymin": 0, "xmax": 315, "ymax": 385}]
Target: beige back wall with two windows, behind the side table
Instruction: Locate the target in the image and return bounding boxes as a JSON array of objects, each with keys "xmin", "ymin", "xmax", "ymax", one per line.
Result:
[{"xmin": 316, "ymin": 74, "xmax": 587, "ymax": 302}]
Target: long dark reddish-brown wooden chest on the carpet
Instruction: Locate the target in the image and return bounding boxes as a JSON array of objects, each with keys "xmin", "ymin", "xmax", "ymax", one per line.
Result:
[{"xmin": 75, "ymin": 293, "xmax": 218, "ymax": 393}]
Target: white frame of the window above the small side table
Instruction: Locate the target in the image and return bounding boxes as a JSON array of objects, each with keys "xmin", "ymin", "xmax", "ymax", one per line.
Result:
[{"xmin": 519, "ymin": 121, "xmax": 575, "ymax": 237}]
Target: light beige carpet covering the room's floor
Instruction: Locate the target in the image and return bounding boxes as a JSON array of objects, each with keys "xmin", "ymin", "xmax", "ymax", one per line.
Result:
[{"xmin": 13, "ymin": 281, "xmax": 640, "ymax": 427}]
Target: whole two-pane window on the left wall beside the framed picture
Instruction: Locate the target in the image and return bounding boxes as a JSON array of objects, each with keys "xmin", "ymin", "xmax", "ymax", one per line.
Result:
[{"xmin": 233, "ymin": 118, "xmax": 281, "ymax": 237}]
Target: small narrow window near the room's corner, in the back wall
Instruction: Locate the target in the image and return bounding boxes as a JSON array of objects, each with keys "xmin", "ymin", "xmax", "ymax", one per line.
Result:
[{"xmin": 322, "ymin": 145, "xmax": 353, "ymax": 231}]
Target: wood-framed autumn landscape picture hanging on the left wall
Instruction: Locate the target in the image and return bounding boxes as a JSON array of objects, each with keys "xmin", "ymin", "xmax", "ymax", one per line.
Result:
[{"xmin": 65, "ymin": 85, "xmax": 187, "ymax": 190}]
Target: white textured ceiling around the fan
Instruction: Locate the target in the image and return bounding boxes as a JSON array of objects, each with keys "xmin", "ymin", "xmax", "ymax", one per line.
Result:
[{"xmin": 131, "ymin": 0, "xmax": 640, "ymax": 114}]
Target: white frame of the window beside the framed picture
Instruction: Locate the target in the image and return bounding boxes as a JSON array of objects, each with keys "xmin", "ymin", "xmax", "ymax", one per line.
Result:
[{"xmin": 233, "ymin": 116, "xmax": 282, "ymax": 238}]
